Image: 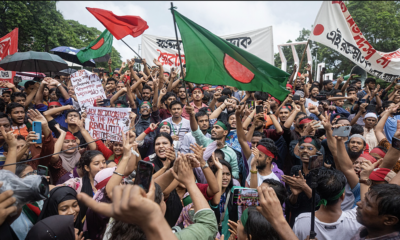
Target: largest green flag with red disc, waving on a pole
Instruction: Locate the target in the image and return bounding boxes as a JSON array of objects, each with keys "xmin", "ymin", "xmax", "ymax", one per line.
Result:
[{"xmin": 173, "ymin": 11, "xmax": 290, "ymax": 101}]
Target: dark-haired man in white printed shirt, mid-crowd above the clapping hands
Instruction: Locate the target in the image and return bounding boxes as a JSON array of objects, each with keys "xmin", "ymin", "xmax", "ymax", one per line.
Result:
[{"xmin": 162, "ymin": 101, "xmax": 190, "ymax": 142}]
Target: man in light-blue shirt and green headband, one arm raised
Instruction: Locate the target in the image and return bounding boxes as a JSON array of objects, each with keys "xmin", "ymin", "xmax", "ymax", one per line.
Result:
[{"xmin": 186, "ymin": 106, "xmax": 239, "ymax": 179}]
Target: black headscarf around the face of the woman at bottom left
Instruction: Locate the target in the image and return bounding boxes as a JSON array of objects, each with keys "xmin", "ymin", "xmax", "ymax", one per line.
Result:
[{"xmin": 38, "ymin": 186, "xmax": 85, "ymax": 230}]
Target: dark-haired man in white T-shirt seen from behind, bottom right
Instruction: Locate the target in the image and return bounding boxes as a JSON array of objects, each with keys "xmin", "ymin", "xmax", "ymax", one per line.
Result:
[{"xmin": 293, "ymin": 169, "xmax": 361, "ymax": 240}]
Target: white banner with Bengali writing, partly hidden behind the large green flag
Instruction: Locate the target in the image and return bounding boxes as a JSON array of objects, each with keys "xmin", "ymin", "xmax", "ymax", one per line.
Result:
[{"xmin": 142, "ymin": 26, "xmax": 274, "ymax": 71}]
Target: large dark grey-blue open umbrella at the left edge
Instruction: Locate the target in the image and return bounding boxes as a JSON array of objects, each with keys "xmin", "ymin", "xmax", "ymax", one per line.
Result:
[{"xmin": 0, "ymin": 51, "xmax": 68, "ymax": 72}]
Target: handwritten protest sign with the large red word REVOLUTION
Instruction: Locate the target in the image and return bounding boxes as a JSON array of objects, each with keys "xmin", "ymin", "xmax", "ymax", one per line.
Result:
[{"xmin": 85, "ymin": 107, "xmax": 131, "ymax": 142}]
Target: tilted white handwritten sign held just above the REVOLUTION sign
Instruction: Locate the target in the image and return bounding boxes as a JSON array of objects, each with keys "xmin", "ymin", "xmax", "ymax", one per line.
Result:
[{"xmin": 71, "ymin": 69, "xmax": 106, "ymax": 109}]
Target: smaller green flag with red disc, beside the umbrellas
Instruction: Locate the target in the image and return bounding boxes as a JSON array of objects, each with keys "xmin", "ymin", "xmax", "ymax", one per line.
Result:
[{"xmin": 76, "ymin": 29, "xmax": 113, "ymax": 63}]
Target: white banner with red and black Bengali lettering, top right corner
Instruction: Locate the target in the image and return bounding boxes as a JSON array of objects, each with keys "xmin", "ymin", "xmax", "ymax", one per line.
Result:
[{"xmin": 310, "ymin": 1, "xmax": 400, "ymax": 82}]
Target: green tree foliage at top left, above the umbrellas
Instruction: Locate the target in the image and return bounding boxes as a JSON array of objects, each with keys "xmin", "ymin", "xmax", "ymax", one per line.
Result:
[{"xmin": 0, "ymin": 1, "xmax": 122, "ymax": 70}]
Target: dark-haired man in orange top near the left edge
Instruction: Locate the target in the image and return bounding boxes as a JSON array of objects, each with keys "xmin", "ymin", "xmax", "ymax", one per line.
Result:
[{"xmin": 7, "ymin": 103, "xmax": 28, "ymax": 138}]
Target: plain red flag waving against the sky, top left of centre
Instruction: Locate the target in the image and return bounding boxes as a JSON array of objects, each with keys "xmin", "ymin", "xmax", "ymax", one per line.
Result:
[{"xmin": 86, "ymin": 7, "xmax": 149, "ymax": 40}]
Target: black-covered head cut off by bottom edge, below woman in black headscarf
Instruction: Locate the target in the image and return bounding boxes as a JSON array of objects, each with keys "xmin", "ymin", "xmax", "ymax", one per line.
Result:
[{"xmin": 25, "ymin": 215, "xmax": 75, "ymax": 240}]
